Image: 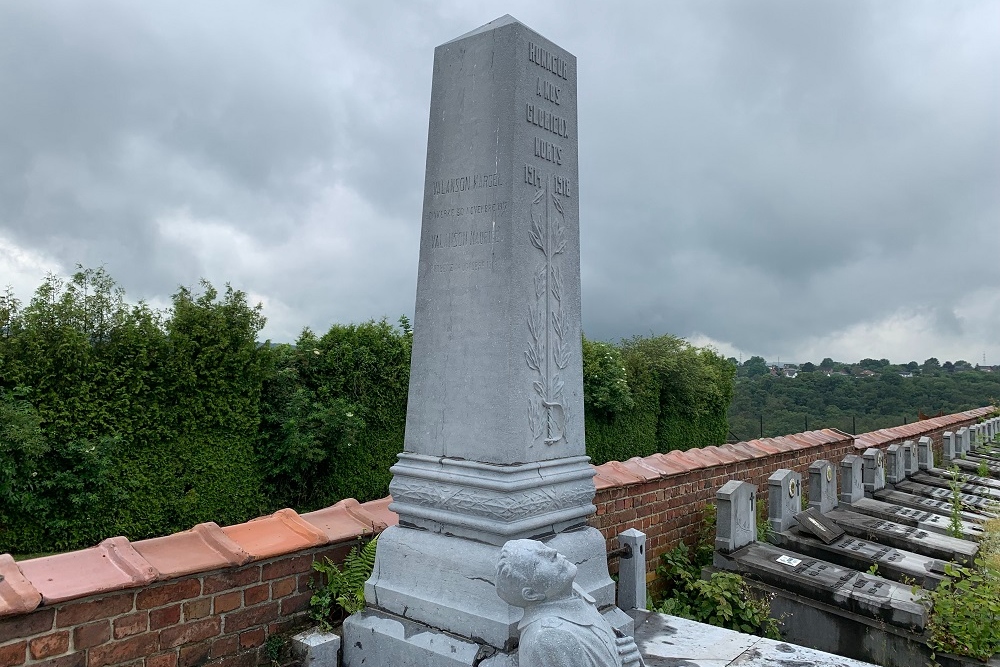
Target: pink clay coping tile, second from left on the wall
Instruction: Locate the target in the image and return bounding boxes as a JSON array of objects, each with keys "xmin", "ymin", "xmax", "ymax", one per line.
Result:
[{"xmin": 19, "ymin": 537, "xmax": 158, "ymax": 604}]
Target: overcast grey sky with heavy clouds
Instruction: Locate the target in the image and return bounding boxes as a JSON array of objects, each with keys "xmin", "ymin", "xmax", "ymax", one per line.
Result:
[{"xmin": 0, "ymin": 0, "xmax": 1000, "ymax": 364}]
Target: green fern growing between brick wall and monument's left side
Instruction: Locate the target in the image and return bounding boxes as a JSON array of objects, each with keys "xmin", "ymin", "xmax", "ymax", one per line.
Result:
[{"xmin": 309, "ymin": 538, "xmax": 378, "ymax": 632}]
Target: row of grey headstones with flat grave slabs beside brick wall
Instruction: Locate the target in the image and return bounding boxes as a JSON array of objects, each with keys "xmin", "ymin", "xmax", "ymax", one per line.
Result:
[{"xmin": 713, "ymin": 420, "xmax": 1000, "ymax": 633}]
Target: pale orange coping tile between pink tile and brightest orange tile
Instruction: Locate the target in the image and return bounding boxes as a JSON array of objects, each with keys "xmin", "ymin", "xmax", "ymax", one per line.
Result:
[{"xmin": 132, "ymin": 522, "xmax": 250, "ymax": 579}]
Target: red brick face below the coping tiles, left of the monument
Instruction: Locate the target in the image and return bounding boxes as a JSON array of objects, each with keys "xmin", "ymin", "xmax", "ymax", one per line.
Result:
[{"xmin": 0, "ymin": 545, "xmax": 360, "ymax": 667}]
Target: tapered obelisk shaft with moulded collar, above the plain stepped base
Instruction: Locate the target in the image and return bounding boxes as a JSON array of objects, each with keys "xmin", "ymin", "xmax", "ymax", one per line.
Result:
[{"xmin": 390, "ymin": 17, "xmax": 594, "ymax": 545}]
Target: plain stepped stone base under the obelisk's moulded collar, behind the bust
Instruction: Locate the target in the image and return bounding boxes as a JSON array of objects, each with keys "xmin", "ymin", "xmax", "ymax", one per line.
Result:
[{"xmin": 344, "ymin": 526, "xmax": 633, "ymax": 667}]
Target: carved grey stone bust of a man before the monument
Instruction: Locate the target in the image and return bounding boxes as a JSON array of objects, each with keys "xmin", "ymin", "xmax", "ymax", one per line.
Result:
[{"xmin": 496, "ymin": 540, "xmax": 642, "ymax": 667}]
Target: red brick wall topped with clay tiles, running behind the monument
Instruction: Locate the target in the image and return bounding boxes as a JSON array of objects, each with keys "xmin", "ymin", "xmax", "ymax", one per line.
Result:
[{"xmin": 0, "ymin": 408, "xmax": 990, "ymax": 667}]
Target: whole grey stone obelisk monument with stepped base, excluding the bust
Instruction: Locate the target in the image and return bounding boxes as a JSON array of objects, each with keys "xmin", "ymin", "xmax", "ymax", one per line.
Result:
[{"xmin": 344, "ymin": 16, "xmax": 630, "ymax": 667}]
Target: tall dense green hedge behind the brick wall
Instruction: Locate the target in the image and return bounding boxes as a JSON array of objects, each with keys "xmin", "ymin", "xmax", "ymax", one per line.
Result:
[{"xmin": 0, "ymin": 269, "xmax": 732, "ymax": 553}]
